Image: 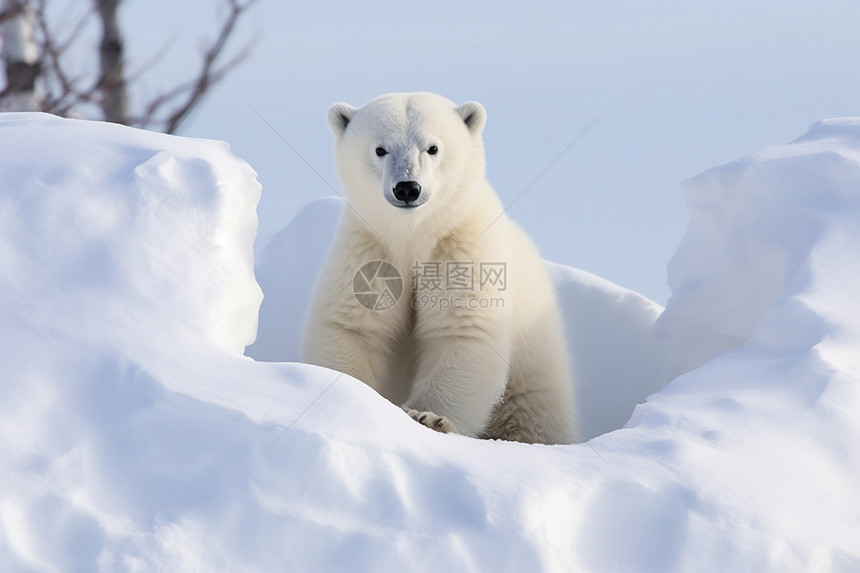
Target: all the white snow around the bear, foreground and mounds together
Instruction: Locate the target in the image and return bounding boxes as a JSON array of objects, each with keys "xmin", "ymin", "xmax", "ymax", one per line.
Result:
[{"xmin": 0, "ymin": 110, "xmax": 860, "ymax": 572}]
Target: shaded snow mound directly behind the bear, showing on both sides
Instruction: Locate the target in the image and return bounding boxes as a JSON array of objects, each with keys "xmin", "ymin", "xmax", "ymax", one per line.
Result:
[{"xmin": 245, "ymin": 197, "xmax": 667, "ymax": 440}]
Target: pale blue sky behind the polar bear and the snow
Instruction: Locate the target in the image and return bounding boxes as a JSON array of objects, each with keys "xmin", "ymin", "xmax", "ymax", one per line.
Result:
[{"xmin": 123, "ymin": 0, "xmax": 860, "ymax": 303}]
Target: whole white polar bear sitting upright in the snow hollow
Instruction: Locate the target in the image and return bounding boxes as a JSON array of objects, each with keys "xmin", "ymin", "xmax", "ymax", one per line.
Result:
[{"xmin": 303, "ymin": 93, "xmax": 576, "ymax": 444}]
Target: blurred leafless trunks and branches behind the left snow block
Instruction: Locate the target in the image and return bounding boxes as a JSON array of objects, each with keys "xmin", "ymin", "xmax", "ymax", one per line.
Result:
[{"xmin": 0, "ymin": 0, "xmax": 257, "ymax": 133}]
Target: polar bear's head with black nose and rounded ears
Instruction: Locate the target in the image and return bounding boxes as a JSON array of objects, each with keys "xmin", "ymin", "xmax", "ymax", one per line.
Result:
[{"xmin": 328, "ymin": 93, "xmax": 486, "ymax": 212}]
